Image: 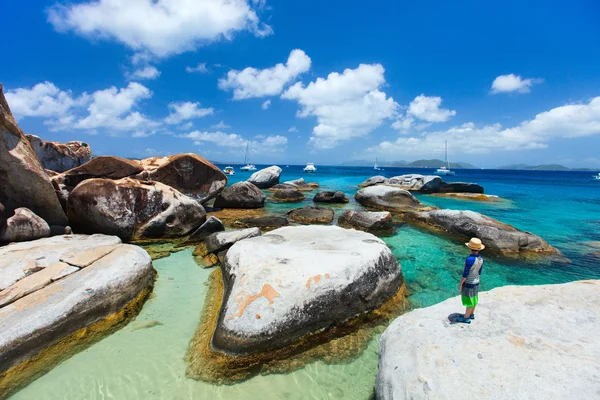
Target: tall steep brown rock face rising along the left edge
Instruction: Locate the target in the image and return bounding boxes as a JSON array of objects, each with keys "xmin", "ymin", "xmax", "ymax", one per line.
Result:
[{"xmin": 0, "ymin": 84, "xmax": 67, "ymax": 225}]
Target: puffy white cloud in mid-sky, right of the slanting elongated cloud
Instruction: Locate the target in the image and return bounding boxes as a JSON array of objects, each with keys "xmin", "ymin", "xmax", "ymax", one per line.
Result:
[{"xmin": 281, "ymin": 64, "xmax": 398, "ymax": 149}]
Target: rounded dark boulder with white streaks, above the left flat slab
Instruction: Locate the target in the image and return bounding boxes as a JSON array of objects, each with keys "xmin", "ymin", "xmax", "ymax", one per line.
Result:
[{"xmin": 67, "ymin": 178, "xmax": 206, "ymax": 240}]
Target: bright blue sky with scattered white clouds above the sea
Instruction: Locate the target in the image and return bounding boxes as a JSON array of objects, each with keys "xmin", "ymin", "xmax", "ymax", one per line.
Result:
[{"xmin": 0, "ymin": 0, "xmax": 600, "ymax": 168}]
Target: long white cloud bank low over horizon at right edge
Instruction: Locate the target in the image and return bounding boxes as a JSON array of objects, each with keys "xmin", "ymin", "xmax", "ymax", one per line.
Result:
[{"xmin": 369, "ymin": 97, "xmax": 600, "ymax": 155}]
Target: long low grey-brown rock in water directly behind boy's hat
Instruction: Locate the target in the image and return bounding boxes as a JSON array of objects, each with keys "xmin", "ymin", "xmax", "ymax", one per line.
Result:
[{"xmin": 409, "ymin": 210, "xmax": 558, "ymax": 255}]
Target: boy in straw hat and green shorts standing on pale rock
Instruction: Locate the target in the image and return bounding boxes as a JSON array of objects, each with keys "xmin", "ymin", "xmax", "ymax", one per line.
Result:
[{"xmin": 456, "ymin": 238, "xmax": 485, "ymax": 324}]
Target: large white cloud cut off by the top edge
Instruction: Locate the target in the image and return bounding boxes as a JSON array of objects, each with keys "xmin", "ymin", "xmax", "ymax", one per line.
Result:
[{"xmin": 48, "ymin": 0, "xmax": 273, "ymax": 57}]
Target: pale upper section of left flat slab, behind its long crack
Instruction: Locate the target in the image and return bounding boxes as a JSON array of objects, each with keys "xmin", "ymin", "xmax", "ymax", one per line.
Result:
[{"xmin": 0, "ymin": 235, "xmax": 121, "ymax": 290}]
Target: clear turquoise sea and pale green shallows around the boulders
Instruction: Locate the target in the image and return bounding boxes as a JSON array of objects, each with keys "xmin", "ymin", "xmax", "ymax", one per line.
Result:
[{"xmin": 11, "ymin": 166, "xmax": 600, "ymax": 400}]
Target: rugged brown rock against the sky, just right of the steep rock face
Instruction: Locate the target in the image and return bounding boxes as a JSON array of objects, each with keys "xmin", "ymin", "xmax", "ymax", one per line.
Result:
[{"xmin": 26, "ymin": 135, "xmax": 92, "ymax": 172}]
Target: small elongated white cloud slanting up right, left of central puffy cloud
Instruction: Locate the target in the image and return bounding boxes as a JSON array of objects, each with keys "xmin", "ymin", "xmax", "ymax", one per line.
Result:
[{"xmin": 219, "ymin": 49, "xmax": 311, "ymax": 100}]
